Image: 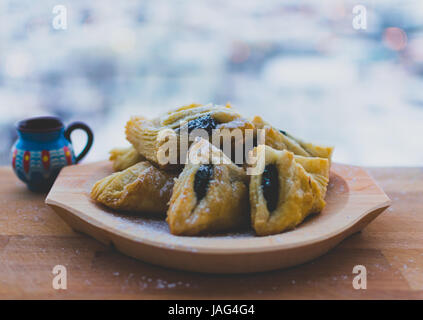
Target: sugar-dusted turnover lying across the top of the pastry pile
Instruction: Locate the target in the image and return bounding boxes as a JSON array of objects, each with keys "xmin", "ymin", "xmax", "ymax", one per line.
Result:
[{"xmin": 126, "ymin": 104, "xmax": 254, "ymax": 167}]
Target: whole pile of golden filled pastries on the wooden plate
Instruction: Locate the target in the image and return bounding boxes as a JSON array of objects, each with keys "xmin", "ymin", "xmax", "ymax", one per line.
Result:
[{"xmin": 91, "ymin": 104, "xmax": 333, "ymax": 236}]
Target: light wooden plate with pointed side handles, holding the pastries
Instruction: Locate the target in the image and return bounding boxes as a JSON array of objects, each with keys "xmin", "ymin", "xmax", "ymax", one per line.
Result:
[{"xmin": 46, "ymin": 161, "xmax": 390, "ymax": 273}]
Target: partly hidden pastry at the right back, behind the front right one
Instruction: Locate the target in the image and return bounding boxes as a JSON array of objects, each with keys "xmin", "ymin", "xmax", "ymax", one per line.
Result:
[{"xmin": 252, "ymin": 116, "xmax": 333, "ymax": 162}]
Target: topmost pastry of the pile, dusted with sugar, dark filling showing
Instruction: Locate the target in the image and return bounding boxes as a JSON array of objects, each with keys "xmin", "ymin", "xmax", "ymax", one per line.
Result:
[{"xmin": 126, "ymin": 104, "xmax": 254, "ymax": 168}]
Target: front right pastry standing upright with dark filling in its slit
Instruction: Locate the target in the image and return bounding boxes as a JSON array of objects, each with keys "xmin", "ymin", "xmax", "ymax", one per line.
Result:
[{"xmin": 249, "ymin": 145, "xmax": 329, "ymax": 236}]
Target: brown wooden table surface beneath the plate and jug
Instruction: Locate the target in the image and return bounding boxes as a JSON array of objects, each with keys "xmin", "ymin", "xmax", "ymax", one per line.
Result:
[{"xmin": 0, "ymin": 167, "xmax": 423, "ymax": 299}]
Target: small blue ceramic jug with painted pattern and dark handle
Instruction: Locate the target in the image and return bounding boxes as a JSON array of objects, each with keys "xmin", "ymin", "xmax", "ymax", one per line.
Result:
[{"xmin": 12, "ymin": 117, "xmax": 93, "ymax": 192}]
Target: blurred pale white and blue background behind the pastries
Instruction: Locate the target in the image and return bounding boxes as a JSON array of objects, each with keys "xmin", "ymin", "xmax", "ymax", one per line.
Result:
[{"xmin": 0, "ymin": 0, "xmax": 423, "ymax": 166}]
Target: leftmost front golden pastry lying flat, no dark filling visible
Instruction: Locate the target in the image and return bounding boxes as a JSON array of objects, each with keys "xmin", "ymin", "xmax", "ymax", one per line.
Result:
[{"xmin": 91, "ymin": 161, "xmax": 176, "ymax": 213}]
